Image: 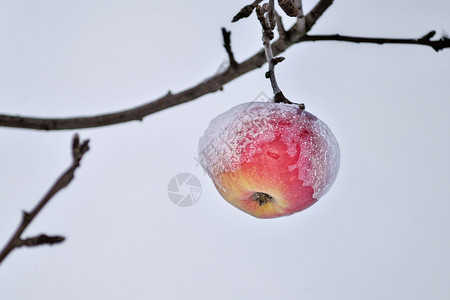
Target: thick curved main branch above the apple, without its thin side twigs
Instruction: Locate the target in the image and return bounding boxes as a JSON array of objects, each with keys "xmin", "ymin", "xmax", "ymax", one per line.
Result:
[{"xmin": 0, "ymin": 0, "xmax": 333, "ymax": 130}]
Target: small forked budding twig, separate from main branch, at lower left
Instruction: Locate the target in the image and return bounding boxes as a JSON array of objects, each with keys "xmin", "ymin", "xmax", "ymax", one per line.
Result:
[{"xmin": 0, "ymin": 134, "xmax": 89, "ymax": 264}]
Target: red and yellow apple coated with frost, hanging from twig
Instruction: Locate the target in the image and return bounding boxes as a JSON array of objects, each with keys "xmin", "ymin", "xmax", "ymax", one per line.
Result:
[{"xmin": 198, "ymin": 102, "xmax": 340, "ymax": 218}]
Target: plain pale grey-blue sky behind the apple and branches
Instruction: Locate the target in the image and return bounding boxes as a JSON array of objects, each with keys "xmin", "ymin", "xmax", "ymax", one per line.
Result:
[{"xmin": 0, "ymin": 0, "xmax": 450, "ymax": 300}]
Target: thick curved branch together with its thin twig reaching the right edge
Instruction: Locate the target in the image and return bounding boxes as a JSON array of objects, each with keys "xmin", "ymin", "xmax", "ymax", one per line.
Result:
[{"xmin": 0, "ymin": 0, "xmax": 450, "ymax": 130}]
